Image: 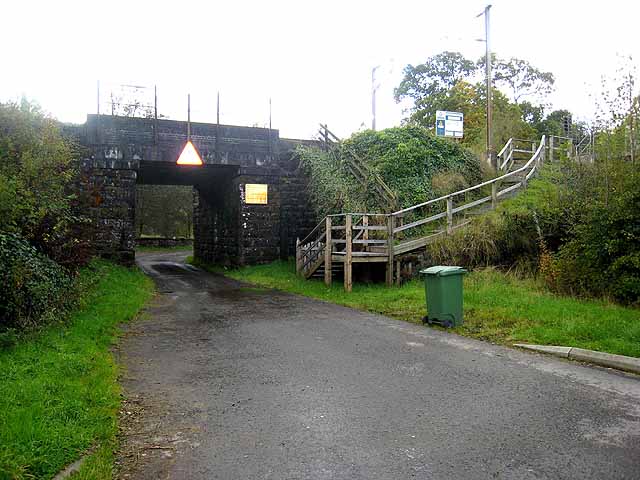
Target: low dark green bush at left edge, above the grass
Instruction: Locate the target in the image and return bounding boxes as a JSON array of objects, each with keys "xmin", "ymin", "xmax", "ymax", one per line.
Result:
[{"xmin": 0, "ymin": 233, "xmax": 73, "ymax": 338}]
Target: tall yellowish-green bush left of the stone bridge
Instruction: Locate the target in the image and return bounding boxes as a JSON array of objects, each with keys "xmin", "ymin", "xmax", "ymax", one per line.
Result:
[{"xmin": 0, "ymin": 99, "xmax": 88, "ymax": 267}]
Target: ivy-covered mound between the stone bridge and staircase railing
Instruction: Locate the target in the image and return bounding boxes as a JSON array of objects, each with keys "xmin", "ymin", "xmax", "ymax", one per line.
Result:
[{"xmin": 298, "ymin": 126, "xmax": 481, "ymax": 216}]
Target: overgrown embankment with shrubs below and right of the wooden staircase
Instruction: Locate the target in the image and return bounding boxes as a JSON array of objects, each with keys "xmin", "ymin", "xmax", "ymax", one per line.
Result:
[{"xmin": 429, "ymin": 161, "xmax": 640, "ymax": 306}]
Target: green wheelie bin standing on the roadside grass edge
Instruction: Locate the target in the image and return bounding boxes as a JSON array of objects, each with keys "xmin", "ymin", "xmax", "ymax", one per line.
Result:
[{"xmin": 420, "ymin": 265, "xmax": 467, "ymax": 327}]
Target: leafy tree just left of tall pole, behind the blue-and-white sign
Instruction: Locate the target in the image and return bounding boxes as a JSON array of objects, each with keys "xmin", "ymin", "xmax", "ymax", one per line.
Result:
[{"xmin": 394, "ymin": 52, "xmax": 476, "ymax": 127}]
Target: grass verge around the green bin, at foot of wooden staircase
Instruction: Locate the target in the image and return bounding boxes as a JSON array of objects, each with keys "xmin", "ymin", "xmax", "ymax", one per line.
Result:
[{"xmin": 204, "ymin": 262, "xmax": 640, "ymax": 357}]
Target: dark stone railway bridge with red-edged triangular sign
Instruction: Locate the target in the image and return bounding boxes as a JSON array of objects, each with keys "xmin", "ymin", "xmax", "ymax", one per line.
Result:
[{"xmin": 70, "ymin": 115, "xmax": 315, "ymax": 265}]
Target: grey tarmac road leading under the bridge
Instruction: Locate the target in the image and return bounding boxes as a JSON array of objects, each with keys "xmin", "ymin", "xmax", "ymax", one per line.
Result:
[{"xmin": 119, "ymin": 253, "xmax": 640, "ymax": 480}]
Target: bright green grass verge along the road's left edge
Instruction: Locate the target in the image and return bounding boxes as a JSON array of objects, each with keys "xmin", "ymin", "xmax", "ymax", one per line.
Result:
[{"xmin": 0, "ymin": 261, "xmax": 153, "ymax": 480}]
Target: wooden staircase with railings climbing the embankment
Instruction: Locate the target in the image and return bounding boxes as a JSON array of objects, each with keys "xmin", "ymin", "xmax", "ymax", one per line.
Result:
[{"xmin": 296, "ymin": 136, "xmax": 564, "ymax": 291}]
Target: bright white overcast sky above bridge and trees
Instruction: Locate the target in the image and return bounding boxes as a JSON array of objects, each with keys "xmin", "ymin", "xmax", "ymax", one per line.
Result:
[{"xmin": 0, "ymin": 0, "xmax": 640, "ymax": 138}]
